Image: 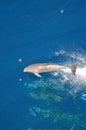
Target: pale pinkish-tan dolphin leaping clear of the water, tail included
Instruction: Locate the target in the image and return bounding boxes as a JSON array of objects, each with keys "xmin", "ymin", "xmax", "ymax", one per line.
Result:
[{"xmin": 23, "ymin": 62, "xmax": 78, "ymax": 77}]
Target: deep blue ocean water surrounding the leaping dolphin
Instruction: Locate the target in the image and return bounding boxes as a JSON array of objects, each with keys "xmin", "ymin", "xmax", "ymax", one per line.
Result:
[{"xmin": 0, "ymin": 0, "xmax": 86, "ymax": 130}]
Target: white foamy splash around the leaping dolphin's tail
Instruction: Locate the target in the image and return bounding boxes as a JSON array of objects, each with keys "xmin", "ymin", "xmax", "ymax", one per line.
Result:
[{"xmin": 52, "ymin": 50, "xmax": 86, "ymax": 94}]
